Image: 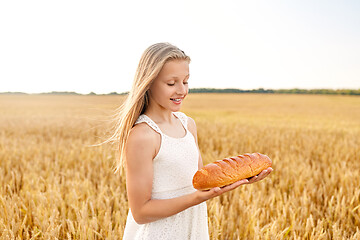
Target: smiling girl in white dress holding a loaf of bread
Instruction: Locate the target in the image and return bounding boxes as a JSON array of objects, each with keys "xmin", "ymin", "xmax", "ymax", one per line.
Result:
[{"xmin": 114, "ymin": 43, "xmax": 272, "ymax": 240}]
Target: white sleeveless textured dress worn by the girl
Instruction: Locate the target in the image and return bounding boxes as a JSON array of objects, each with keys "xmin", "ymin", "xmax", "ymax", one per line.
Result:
[{"xmin": 123, "ymin": 112, "xmax": 209, "ymax": 240}]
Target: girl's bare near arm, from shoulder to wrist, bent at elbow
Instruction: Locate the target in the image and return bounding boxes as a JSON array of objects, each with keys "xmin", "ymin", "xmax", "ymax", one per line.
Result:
[{"xmin": 126, "ymin": 124, "xmax": 205, "ymax": 224}]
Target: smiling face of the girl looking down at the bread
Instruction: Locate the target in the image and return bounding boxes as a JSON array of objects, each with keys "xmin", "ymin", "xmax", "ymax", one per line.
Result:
[{"xmin": 149, "ymin": 60, "xmax": 189, "ymax": 112}]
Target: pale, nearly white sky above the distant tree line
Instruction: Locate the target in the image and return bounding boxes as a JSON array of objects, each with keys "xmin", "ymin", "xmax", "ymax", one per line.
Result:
[{"xmin": 0, "ymin": 0, "xmax": 360, "ymax": 94}]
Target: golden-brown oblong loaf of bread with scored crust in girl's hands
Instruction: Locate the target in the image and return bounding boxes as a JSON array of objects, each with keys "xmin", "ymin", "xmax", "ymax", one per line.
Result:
[{"xmin": 193, "ymin": 153, "xmax": 272, "ymax": 190}]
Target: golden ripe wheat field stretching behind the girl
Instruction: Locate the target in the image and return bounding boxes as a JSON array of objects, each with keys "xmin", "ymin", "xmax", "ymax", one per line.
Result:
[{"xmin": 0, "ymin": 94, "xmax": 360, "ymax": 240}]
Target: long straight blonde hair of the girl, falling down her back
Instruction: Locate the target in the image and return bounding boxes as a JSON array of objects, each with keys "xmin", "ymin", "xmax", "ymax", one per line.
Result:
[{"xmin": 107, "ymin": 43, "xmax": 191, "ymax": 174}]
